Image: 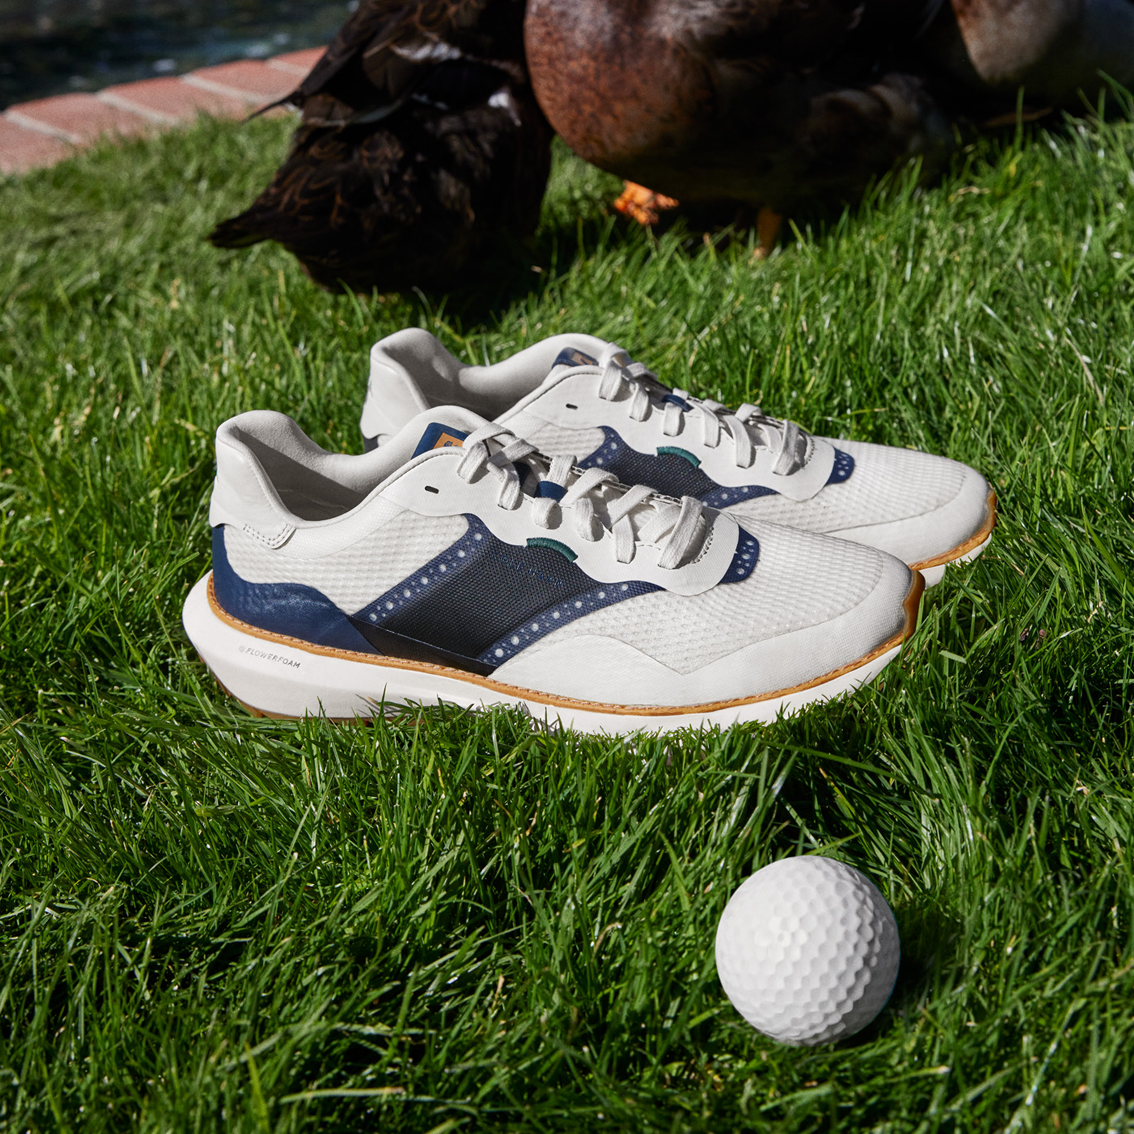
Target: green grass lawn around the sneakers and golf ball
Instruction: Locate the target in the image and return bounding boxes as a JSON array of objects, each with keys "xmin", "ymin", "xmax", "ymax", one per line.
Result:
[{"xmin": 0, "ymin": 108, "xmax": 1134, "ymax": 1134}]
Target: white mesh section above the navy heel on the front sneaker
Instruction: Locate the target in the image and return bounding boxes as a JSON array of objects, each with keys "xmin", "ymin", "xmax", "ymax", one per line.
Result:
[{"xmin": 225, "ymin": 511, "xmax": 468, "ymax": 613}]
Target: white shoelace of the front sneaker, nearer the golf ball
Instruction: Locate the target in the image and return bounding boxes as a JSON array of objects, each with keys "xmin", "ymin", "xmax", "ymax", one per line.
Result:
[{"xmin": 457, "ymin": 422, "xmax": 708, "ymax": 570}]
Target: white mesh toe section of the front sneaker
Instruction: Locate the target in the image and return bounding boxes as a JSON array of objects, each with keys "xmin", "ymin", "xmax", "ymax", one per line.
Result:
[{"xmin": 521, "ymin": 523, "xmax": 904, "ymax": 674}]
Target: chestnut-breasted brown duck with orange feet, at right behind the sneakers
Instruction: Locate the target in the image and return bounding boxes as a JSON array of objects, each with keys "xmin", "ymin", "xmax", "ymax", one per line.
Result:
[{"xmin": 524, "ymin": 0, "xmax": 1134, "ymax": 257}]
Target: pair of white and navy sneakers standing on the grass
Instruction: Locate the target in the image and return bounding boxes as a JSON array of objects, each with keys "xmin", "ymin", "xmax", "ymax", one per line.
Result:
[{"xmin": 184, "ymin": 329, "xmax": 996, "ymax": 734}]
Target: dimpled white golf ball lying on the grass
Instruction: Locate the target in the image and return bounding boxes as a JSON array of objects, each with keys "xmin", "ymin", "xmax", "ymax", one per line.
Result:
[{"xmin": 717, "ymin": 855, "xmax": 902, "ymax": 1046}]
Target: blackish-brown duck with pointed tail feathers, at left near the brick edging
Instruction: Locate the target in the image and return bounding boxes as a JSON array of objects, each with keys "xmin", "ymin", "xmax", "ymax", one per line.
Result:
[{"xmin": 209, "ymin": 0, "xmax": 551, "ymax": 291}]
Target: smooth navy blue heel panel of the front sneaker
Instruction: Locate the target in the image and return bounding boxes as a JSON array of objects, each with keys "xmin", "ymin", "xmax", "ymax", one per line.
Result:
[{"xmin": 213, "ymin": 525, "xmax": 376, "ymax": 653}]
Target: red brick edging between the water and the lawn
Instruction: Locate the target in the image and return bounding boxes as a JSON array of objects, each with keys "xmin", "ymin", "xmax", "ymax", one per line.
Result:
[{"xmin": 0, "ymin": 48, "xmax": 323, "ymax": 174}]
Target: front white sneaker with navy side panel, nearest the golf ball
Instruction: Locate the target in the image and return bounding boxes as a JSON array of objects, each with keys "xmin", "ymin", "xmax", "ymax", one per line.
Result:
[{"xmin": 184, "ymin": 407, "xmax": 923, "ymax": 733}]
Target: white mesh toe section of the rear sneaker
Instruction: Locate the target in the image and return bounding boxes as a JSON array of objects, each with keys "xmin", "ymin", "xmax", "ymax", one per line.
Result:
[{"xmin": 729, "ymin": 441, "xmax": 968, "ymax": 532}]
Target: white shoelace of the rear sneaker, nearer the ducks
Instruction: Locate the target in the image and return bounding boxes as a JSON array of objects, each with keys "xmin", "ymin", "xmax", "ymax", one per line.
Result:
[{"xmin": 599, "ymin": 342, "xmax": 806, "ymax": 475}]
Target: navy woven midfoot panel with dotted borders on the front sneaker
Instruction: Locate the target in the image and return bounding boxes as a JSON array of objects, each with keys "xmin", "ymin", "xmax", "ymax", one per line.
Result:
[{"xmin": 354, "ymin": 515, "xmax": 657, "ymax": 666}]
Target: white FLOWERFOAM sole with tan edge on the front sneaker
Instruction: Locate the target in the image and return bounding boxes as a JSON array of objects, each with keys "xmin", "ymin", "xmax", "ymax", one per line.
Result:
[{"xmin": 181, "ymin": 572, "xmax": 925, "ymax": 735}]
